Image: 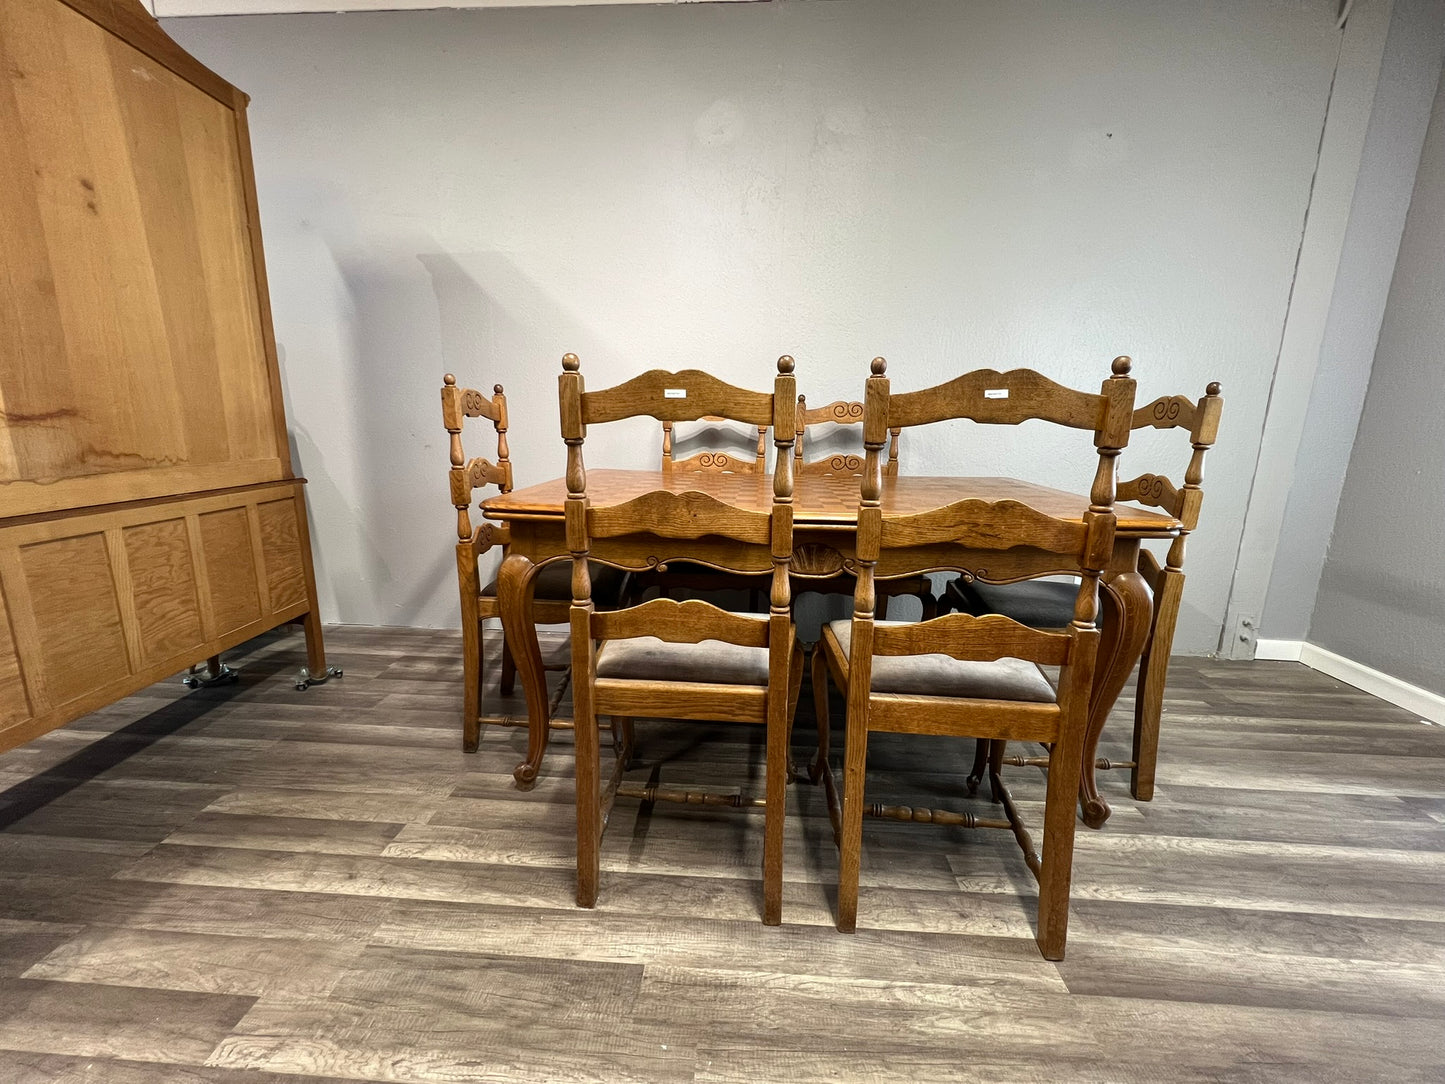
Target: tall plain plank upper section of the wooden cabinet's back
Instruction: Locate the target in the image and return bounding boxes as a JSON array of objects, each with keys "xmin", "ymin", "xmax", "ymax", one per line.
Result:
[{"xmin": 0, "ymin": 0, "xmax": 282, "ymax": 515}]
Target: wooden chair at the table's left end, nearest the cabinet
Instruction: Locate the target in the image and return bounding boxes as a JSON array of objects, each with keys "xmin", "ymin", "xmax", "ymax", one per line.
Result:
[{"xmin": 442, "ymin": 373, "xmax": 626, "ymax": 753}]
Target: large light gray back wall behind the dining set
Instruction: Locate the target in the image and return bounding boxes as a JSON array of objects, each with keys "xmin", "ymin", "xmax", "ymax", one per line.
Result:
[{"xmin": 166, "ymin": 0, "xmax": 1340, "ymax": 652}]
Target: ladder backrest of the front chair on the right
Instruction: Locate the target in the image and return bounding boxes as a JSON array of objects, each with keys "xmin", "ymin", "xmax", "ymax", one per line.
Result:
[{"xmin": 850, "ymin": 358, "xmax": 1134, "ymax": 695}]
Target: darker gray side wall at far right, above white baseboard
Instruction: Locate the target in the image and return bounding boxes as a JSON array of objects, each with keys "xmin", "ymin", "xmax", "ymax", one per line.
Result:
[{"xmin": 1309, "ymin": 67, "xmax": 1445, "ymax": 694}]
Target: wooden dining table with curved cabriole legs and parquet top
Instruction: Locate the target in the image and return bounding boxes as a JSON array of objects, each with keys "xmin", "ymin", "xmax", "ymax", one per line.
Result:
[{"xmin": 481, "ymin": 470, "xmax": 1179, "ymax": 828}]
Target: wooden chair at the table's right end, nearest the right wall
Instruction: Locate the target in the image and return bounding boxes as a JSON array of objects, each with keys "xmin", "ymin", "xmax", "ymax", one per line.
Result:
[{"xmin": 949, "ymin": 383, "xmax": 1224, "ymax": 802}]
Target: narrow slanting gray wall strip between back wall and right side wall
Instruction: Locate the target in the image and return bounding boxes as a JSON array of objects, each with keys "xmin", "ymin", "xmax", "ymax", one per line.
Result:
[{"xmin": 1260, "ymin": 0, "xmax": 1445, "ymax": 640}]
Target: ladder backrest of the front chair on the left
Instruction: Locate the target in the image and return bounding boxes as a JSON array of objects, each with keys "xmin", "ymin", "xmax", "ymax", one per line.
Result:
[{"xmin": 558, "ymin": 354, "xmax": 798, "ymax": 650}]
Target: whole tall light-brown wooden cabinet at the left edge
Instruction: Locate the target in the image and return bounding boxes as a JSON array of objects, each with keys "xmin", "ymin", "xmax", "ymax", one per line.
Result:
[{"xmin": 0, "ymin": 0, "xmax": 328, "ymax": 750}]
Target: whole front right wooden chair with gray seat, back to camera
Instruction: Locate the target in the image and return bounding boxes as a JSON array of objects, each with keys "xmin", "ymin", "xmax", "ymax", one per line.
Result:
[{"xmin": 812, "ymin": 358, "xmax": 1134, "ymax": 960}]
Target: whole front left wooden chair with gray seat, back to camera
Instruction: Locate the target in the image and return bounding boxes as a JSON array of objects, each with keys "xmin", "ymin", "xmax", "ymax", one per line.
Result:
[{"xmin": 558, "ymin": 354, "xmax": 802, "ymax": 925}]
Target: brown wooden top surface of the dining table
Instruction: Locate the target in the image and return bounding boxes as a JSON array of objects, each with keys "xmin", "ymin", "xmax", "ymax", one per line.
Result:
[{"xmin": 481, "ymin": 470, "xmax": 1179, "ymax": 538}]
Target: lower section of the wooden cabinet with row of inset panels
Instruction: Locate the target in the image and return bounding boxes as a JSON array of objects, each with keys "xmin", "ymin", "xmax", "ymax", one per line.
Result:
[{"xmin": 0, "ymin": 481, "xmax": 314, "ymax": 747}]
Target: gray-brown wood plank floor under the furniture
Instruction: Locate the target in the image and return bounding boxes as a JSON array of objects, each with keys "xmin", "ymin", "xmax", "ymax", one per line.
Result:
[{"xmin": 0, "ymin": 627, "xmax": 1445, "ymax": 1084}]
